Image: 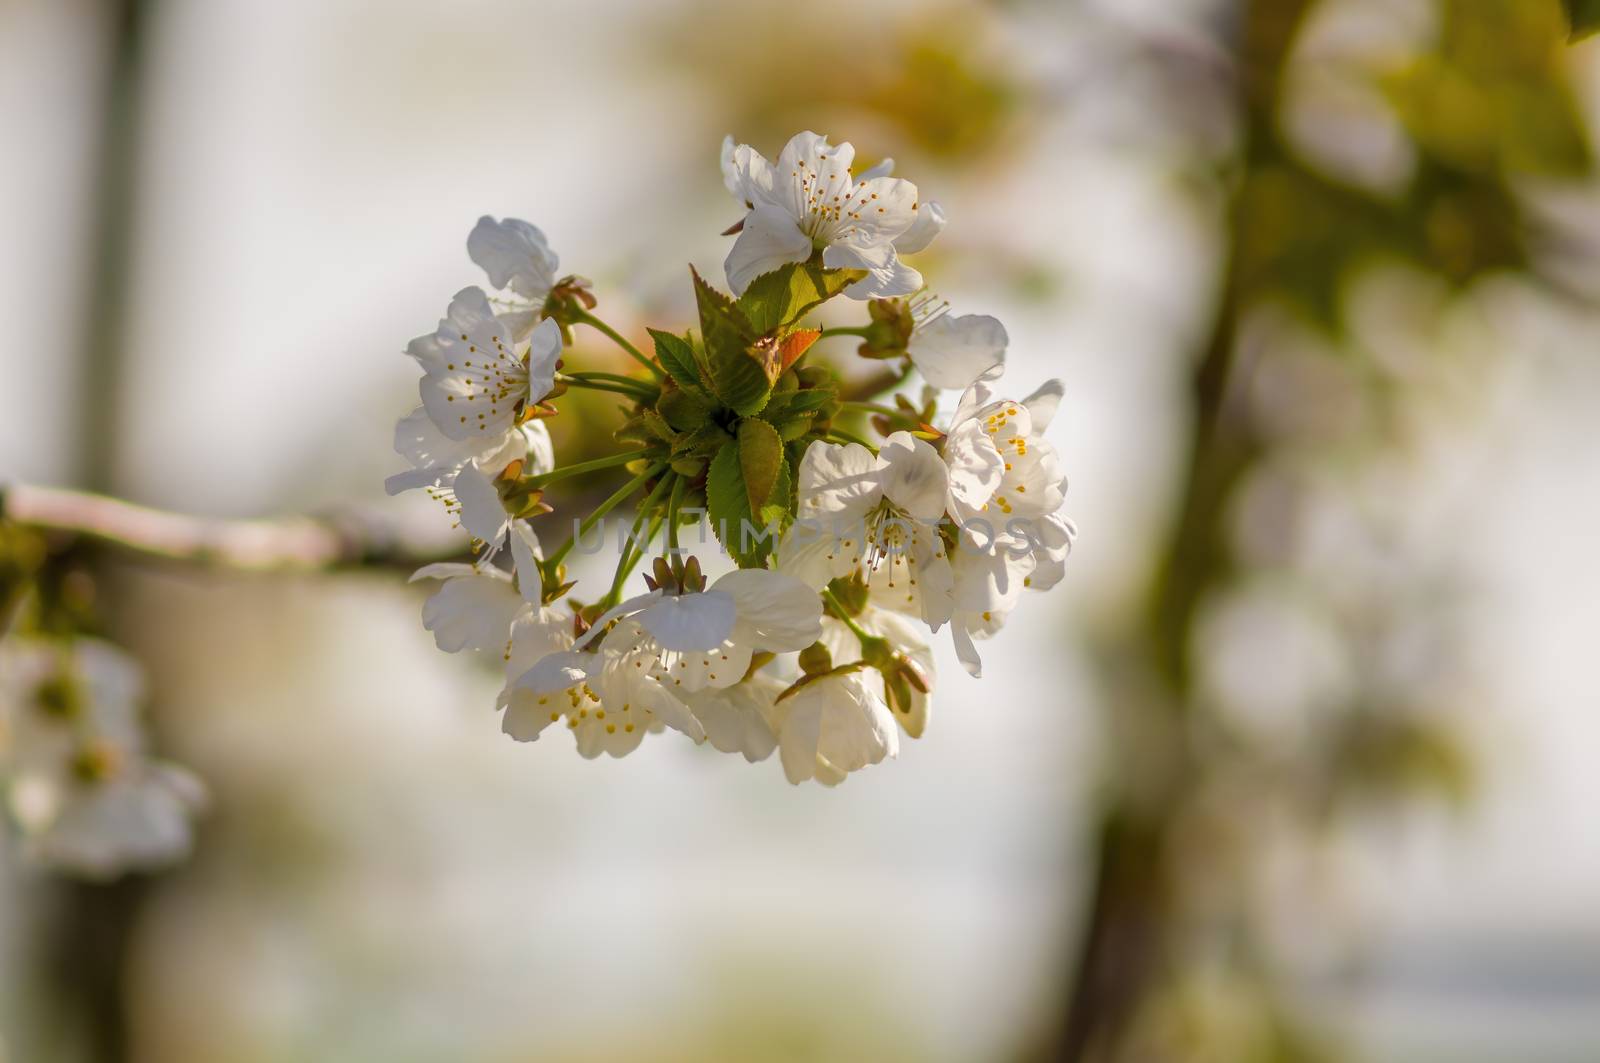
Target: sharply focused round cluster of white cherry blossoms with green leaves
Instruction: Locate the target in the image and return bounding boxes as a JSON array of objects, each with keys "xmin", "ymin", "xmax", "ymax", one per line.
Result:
[{"xmin": 387, "ymin": 133, "xmax": 1075, "ymax": 784}]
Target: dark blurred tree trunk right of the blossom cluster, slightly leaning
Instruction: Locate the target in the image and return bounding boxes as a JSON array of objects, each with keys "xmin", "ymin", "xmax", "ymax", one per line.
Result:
[{"xmin": 1051, "ymin": 0, "xmax": 1310, "ymax": 1060}]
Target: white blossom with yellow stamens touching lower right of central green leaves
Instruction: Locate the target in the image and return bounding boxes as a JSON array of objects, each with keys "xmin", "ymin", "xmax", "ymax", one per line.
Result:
[{"xmin": 778, "ymin": 432, "xmax": 955, "ymax": 629}]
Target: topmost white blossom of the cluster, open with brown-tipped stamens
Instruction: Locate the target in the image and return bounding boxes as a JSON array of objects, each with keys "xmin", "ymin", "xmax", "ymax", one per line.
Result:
[{"xmin": 722, "ymin": 133, "xmax": 942, "ymax": 299}]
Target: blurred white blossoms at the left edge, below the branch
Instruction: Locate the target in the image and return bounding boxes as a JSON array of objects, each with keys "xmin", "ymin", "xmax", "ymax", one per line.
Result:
[{"xmin": 0, "ymin": 639, "xmax": 205, "ymax": 877}]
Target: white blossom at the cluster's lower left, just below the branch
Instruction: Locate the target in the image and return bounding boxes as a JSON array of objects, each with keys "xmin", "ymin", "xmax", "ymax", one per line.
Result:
[{"xmin": 411, "ymin": 520, "xmax": 544, "ymax": 653}]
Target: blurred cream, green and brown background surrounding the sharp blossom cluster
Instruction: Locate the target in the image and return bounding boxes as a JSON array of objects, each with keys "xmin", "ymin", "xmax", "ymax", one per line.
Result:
[{"xmin": 0, "ymin": 0, "xmax": 1600, "ymax": 1063}]
